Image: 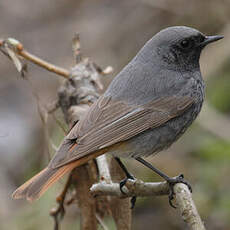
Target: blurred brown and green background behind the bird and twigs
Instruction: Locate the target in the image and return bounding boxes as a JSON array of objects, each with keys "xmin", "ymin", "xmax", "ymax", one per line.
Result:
[{"xmin": 0, "ymin": 0, "xmax": 230, "ymax": 230}]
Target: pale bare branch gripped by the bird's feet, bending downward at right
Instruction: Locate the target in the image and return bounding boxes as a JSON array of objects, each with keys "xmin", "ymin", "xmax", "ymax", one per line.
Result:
[{"xmin": 90, "ymin": 179, "xmax": 205, "ymax": 230}]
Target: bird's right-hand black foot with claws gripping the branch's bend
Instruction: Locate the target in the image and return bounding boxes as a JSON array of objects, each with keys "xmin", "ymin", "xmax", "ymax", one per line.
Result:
[{"xmin": 167, "ymin": 174, "xmax": 192, "ymax": 208}]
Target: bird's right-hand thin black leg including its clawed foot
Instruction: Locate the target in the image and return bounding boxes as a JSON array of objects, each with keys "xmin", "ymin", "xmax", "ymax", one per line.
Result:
[{"xmin": 135, "ymin": 157, "xmax": 192, "ymax": 208}]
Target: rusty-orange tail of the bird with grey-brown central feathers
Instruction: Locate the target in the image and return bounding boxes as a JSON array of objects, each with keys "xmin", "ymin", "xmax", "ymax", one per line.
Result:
[{"xmin": 12, "ymin": 149, "xmax": 106, "ymax": 201}]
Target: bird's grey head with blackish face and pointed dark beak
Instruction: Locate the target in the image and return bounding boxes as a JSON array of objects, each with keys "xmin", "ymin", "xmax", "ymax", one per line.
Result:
[{"xmin": 154, "ymin": 26, "xmax": 223, "ymax": 71}]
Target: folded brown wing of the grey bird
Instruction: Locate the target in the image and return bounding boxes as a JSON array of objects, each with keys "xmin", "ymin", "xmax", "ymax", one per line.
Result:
[{"xmin": 50, "ymin": 96, "xmax": 194, "ymax": 168}]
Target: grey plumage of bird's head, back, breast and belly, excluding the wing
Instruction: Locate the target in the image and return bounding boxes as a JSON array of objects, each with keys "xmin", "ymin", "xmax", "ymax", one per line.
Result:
[{"xmin": 105, "ymin": 27, "xmax": 204, "ymax": 157}]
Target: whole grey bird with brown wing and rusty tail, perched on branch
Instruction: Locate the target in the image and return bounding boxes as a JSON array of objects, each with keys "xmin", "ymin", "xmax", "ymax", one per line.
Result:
[{"xmin": 12, "ymin": 26, "xmax": 223, "ymax": 201}]
